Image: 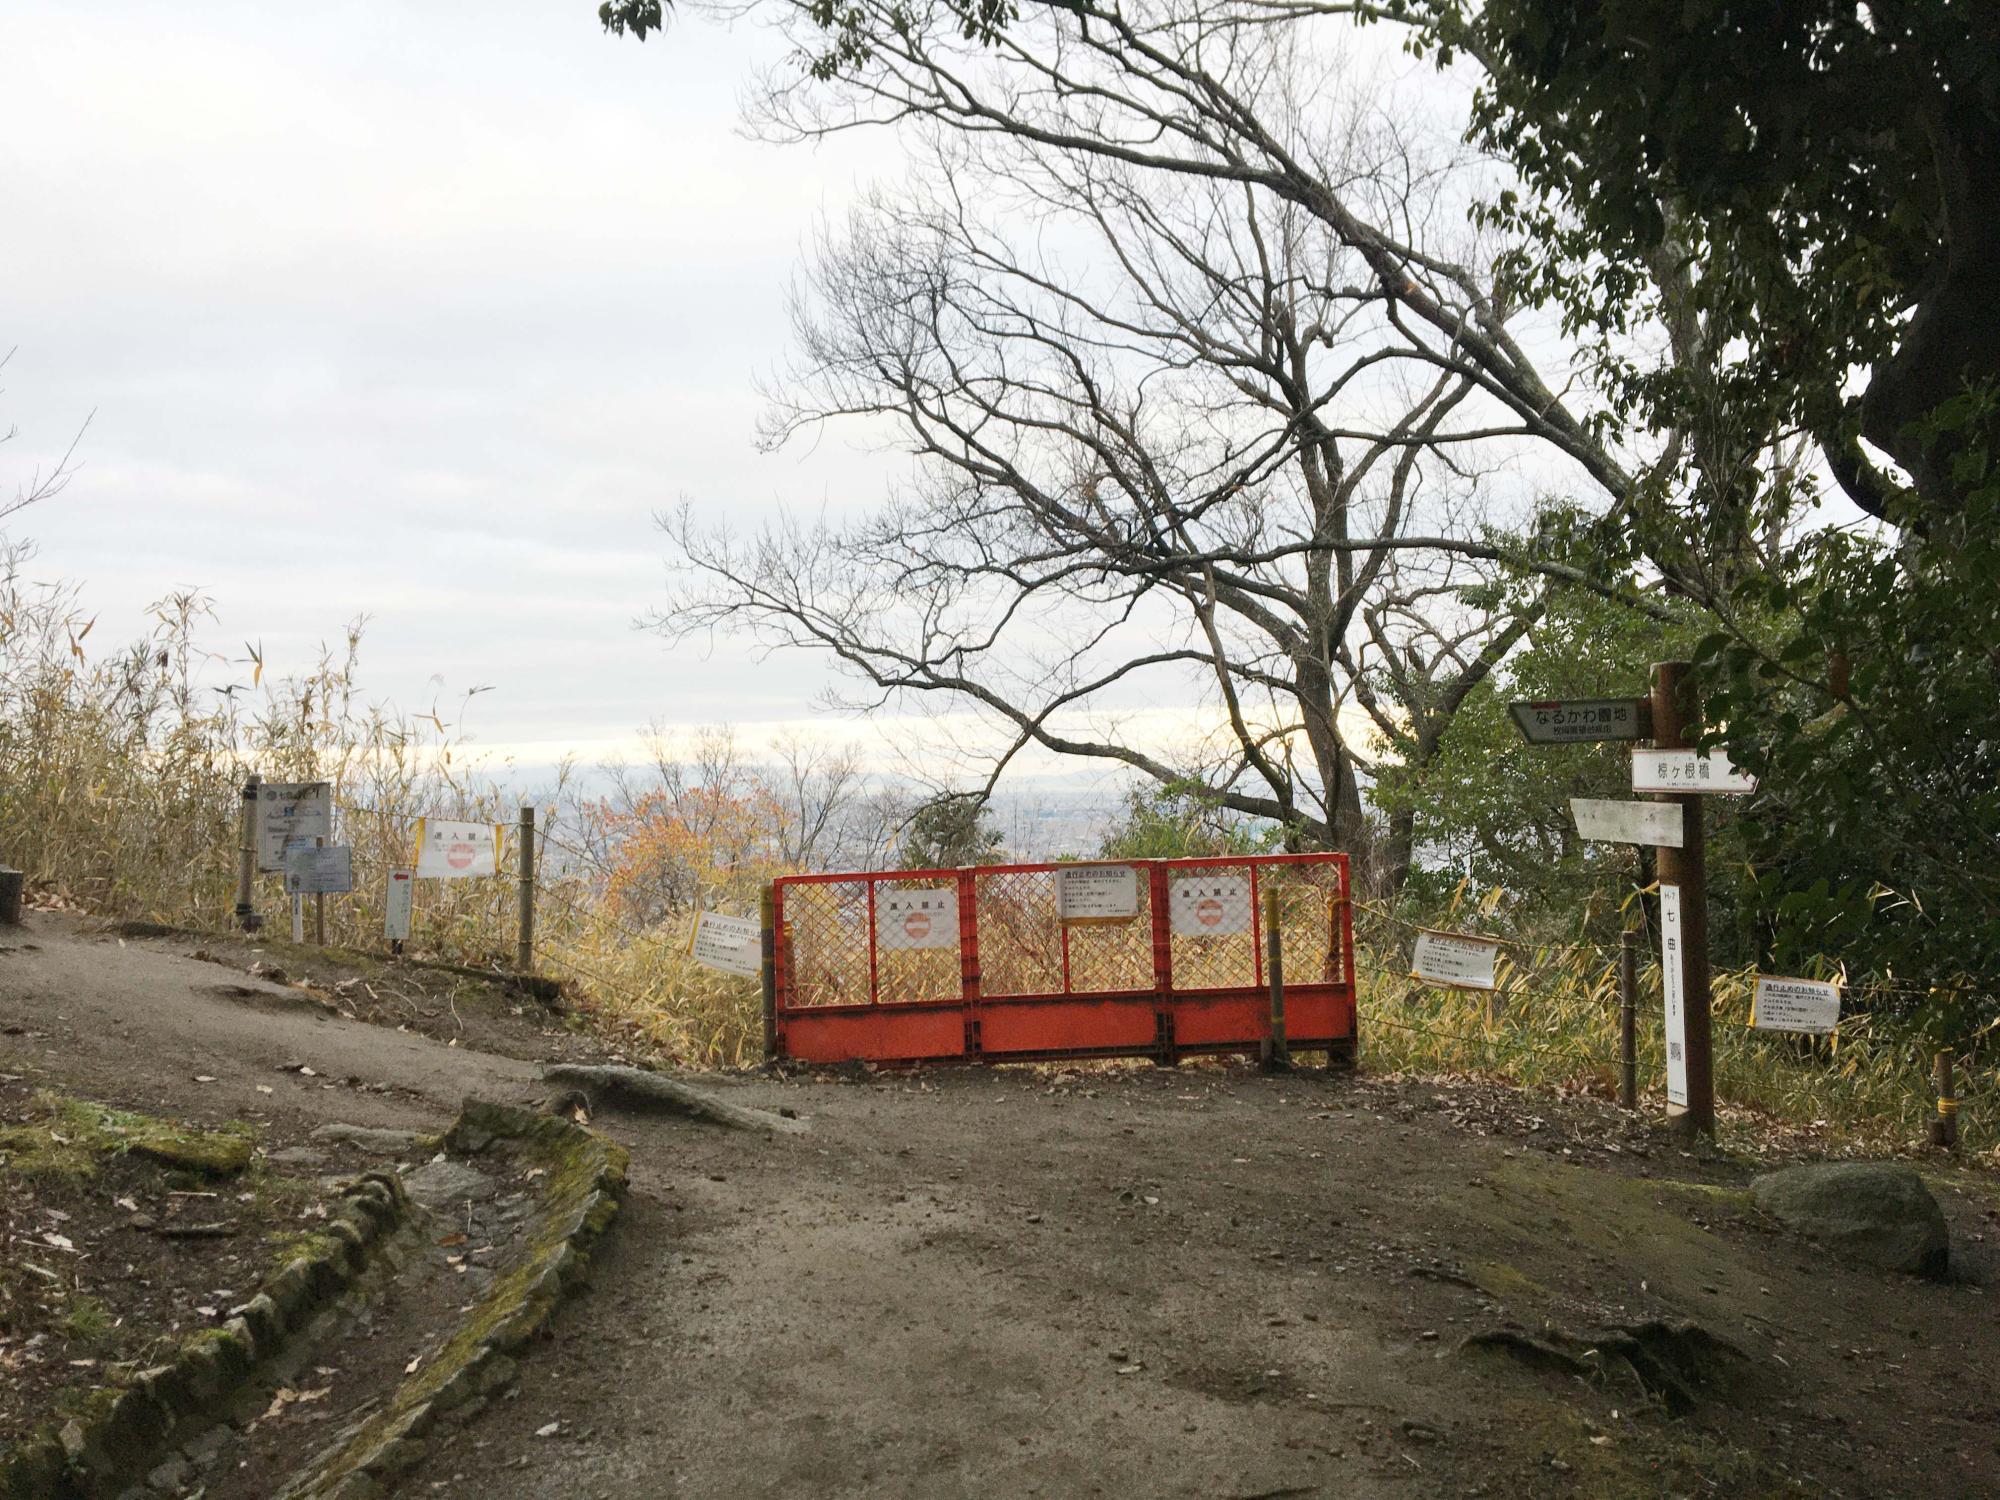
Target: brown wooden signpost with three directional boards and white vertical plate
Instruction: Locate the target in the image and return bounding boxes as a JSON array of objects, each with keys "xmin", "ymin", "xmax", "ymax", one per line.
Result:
[{"xmin": 1510, "ymin": 662, "xmax": 1756, "ymax": 1136}]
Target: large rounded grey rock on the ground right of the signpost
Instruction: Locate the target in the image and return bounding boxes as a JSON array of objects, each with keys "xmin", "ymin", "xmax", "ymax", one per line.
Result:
[{"xmin": 1750, "ymin": 1162, "xmax": 1952, "ymax": 1278}]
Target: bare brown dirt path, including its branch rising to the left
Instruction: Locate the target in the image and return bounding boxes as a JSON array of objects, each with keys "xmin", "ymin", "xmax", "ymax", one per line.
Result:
[{"xmin": 0, "ymin": 916, "xmax": 2000, "ymax": 1500}]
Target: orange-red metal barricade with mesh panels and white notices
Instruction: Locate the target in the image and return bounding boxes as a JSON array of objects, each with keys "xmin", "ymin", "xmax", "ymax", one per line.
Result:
[{"xmin": 770, "ymin": 854, "xmax": 1354, "ymax": 1062}]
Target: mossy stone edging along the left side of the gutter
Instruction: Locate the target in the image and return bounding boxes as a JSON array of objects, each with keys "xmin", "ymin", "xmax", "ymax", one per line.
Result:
[{"xmin": 0, "ymin": 1172, "xmax": 410, "ymax": 1500}]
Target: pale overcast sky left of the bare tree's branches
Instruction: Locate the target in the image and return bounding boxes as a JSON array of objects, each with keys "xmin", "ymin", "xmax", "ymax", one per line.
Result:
[{"xmin": 0, "ymin": 0, "xmax": 952, "ymax": 776}]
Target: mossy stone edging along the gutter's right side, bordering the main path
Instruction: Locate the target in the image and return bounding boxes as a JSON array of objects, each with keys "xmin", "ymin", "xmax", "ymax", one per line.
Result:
[{"xmin": 280, "ymin": 1100, "xmax": 628, "ymax": 1500}]
